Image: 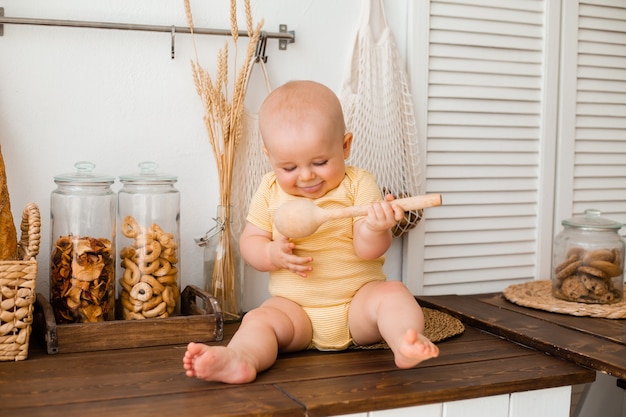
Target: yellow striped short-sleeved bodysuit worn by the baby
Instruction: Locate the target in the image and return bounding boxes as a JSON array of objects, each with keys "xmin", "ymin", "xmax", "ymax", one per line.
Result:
[{"xmin": 247, "ymin": 166, "xmax": 386, "ymax": 350}]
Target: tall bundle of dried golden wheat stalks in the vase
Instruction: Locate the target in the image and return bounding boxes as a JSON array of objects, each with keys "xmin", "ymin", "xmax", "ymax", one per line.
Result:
[{"xmin": 184, "ymin": 0, "xmax": 263, "ymax": 319}]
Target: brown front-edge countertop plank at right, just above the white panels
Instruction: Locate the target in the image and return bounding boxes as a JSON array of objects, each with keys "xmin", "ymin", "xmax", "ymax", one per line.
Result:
[{"xmin": 279, "ymin": 355, "xmax": 589, "ymax": 416}]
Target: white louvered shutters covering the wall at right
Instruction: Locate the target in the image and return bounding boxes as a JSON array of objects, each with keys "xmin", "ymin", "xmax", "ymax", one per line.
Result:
[{"xmin": 403, "ymin": 0, "xmax": 626, "ymax": 294}]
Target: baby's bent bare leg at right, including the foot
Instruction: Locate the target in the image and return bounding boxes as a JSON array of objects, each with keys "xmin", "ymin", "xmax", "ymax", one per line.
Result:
[{"xmin": 349, "ymin": 281, "xmax": 439, "ymax": 368}]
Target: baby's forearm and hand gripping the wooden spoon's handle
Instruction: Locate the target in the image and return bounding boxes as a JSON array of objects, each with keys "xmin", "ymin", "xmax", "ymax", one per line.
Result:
[{"xmin": 353, "ymin": 195, "xmax": 404, "ymax": 259}]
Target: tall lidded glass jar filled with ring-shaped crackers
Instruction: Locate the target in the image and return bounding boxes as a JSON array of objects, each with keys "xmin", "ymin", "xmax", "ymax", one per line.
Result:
[{"xmin": 118, "ymin": 162, "xmax": 180, "ymax": 320}]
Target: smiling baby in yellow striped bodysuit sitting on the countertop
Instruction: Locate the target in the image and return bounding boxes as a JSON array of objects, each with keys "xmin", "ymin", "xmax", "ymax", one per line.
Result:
[{"xmin": 183, "ymin": 81, "xmax": 439, "ymax": 384}]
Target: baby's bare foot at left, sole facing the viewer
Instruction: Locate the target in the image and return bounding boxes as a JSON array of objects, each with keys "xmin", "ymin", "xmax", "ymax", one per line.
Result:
[{"xmin": 183, "ymin": 343, "xmax": 256, "ymax": 384}]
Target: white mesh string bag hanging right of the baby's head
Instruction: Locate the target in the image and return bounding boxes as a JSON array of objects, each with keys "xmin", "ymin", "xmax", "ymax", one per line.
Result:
[{"xmin": 340, "ymin": 0, "xmax": 422, "ymax": 237}]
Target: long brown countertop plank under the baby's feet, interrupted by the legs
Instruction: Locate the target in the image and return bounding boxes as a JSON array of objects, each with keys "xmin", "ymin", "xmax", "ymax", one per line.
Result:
[{"xmin": 0, "ymin": 328, "xmax": 502, "ymax": 408}]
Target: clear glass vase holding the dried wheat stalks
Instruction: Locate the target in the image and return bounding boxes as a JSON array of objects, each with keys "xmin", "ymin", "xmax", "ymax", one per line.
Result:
[{"xmin": 199, "ymin": 206, "xmax": 244, "ymax": 322}]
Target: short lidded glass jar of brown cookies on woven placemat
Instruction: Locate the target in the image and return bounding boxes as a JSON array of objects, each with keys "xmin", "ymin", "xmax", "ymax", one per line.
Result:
[{"xmin": 552, "ymin": 209, "xmax": 624, "ymax": 304}]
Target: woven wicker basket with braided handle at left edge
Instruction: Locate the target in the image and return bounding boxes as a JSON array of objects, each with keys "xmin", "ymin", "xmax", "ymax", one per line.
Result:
[{"xmin": 0, "ymin": 203, "xmax": 41, "ymax": 361}]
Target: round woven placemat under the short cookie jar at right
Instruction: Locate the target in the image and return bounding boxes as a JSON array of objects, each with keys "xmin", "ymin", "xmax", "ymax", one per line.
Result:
[{"xmin": 502, "ymin": 280, "xmax": 626, "ymax": 319}]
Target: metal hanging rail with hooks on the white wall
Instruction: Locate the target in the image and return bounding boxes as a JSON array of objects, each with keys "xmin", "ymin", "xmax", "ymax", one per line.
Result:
[{"xmin": 0, "ymin": 7, "xmax": 296, "ymax": 61}]
